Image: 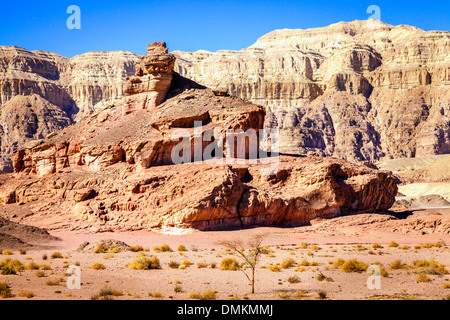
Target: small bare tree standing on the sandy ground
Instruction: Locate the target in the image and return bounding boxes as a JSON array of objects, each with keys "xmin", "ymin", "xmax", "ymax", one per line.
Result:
[{"xmin": 218, "ymin": 234, "xmax": 267, "ymax": 293}]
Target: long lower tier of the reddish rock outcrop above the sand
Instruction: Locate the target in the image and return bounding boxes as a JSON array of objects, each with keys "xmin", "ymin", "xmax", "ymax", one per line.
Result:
[{"xmin": 0, "ymin": 157, "xmax": 397, "ymax": 231}]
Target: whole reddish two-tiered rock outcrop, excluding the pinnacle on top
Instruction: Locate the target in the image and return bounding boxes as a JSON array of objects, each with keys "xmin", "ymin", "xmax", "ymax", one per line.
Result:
[{"xmin": 0, "ymin": 74, "xmax": 397, "ymax": 232}]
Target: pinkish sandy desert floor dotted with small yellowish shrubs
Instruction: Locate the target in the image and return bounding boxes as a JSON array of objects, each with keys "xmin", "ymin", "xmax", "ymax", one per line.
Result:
[{"xmin": 0, "ymin": 208, "xmax": 450, "ymax": 300}]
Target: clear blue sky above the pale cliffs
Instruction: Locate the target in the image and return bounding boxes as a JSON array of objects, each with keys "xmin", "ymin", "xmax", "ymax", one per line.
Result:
[{"xmin": 0, "ymin": 0, "xmax": 450, "ymax": 57}]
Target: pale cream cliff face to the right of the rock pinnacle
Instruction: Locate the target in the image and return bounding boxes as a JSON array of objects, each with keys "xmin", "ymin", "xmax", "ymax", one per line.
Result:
[{"xmin": 173, "ymin": 21, "xmax": 450, "ymax": 161}]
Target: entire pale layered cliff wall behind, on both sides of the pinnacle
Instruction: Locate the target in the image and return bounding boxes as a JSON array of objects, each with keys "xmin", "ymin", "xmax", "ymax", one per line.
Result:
[{"xmin": 0, "ymin": 20, "xmax": 450, "ymax": 172}]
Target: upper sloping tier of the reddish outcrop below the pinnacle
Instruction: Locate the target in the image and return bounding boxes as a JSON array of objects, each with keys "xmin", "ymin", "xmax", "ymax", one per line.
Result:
[{"xmin": 12, "ymin": 81, "xmax": 265, "ymax": 176}]
